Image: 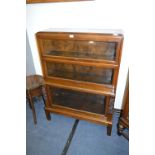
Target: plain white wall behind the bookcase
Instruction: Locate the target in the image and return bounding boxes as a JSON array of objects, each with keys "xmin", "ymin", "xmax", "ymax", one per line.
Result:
[{"xmin": 26, "ymin": 0, "xmax": 129, "ymax": 109}]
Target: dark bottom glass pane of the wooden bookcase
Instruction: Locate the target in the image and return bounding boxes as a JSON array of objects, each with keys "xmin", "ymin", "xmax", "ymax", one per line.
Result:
[{"xmin": 51, "ymin": 88, "xmax": 105, "ymax": 115}]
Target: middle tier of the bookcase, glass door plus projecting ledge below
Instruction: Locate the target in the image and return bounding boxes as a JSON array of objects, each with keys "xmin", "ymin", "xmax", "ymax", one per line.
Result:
[{"xmin": 42, "ymin": 57, "xmax": 118, "ymax": 96}]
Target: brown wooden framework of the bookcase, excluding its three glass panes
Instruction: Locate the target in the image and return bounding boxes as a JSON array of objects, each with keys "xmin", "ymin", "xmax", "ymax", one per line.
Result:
[{"xmin": 36, "ymin": 29, "xmax": 123, "ymax": 135}]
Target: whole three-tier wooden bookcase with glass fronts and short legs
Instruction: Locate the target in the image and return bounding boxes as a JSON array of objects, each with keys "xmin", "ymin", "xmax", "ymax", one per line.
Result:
[{"xmin": 36, "ymin": 29, "xmax": 123, "ymax": 135}]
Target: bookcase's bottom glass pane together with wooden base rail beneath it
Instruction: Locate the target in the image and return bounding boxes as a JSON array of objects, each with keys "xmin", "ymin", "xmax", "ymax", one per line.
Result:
[{"xmin": 45, "ymin": 87, "xmax": 112, "ymax": 125}]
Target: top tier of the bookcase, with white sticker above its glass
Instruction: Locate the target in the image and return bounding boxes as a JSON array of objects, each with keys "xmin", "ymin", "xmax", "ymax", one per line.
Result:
[{"xmin": 36, "ymin": 30, "xmax": 123, "ymax": 63}]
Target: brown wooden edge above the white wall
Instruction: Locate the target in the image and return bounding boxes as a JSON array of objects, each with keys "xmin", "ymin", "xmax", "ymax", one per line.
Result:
[{"xmin": 26, "ymin": 0, "xmax": 93, "ymax": 4}]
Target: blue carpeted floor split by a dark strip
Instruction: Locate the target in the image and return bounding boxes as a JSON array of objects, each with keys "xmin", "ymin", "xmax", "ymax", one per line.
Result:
[{"xmin": 26, "ymin": 99, "xmax": 129, "ymax": 155}]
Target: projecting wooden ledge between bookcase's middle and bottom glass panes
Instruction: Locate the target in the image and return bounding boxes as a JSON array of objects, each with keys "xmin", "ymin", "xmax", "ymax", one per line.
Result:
[{"xmin": 45, "ymin": 77, "xmax": 115, "ymax": 96}]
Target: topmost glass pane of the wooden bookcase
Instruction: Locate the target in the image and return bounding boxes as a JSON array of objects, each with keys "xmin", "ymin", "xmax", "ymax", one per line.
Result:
[{"xmin": 43, "ymin": 40, "xmax": 116, "ymax": 60}]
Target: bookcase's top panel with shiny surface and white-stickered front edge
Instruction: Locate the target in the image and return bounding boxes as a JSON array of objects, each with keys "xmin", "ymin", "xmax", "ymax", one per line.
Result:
[{"xmin": 36, "ymin": 29, "xmax": 123, "ymax": 42}]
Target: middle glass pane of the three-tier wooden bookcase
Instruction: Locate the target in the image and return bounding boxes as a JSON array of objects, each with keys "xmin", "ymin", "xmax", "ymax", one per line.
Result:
[{"xmin": 46, "ymin": 62, "xmax": 113, "ymax": 84}]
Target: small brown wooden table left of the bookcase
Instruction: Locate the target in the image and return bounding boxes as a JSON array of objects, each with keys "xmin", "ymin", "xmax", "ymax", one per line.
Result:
[{"xmin": 26, "ymin": 75, "xmax": 45, "ymax": 124}]
